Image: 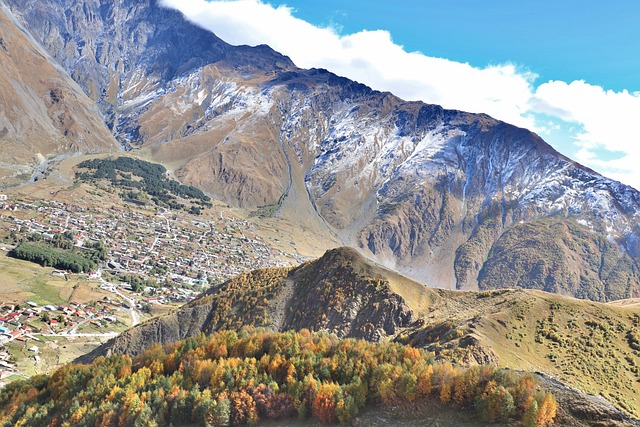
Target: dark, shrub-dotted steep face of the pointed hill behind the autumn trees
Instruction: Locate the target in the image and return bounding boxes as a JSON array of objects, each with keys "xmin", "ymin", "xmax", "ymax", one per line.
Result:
[{"xmin": 76, "ymin": 248, "xmax": 421, "ymax": 360}]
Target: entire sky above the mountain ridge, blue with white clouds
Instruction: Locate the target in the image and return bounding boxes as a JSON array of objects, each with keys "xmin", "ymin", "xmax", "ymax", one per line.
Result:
[{"xmin": 162, "ymin": 0, "xmax": 640, "ymax": 189}]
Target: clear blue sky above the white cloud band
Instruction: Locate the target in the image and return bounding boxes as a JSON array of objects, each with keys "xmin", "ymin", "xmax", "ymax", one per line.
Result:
[{"xmin": 280, "ymin": 0, "xmax": 640, "ymax": 91}]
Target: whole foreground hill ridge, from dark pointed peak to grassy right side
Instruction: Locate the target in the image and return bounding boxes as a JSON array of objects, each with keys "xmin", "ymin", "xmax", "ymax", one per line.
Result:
[{"xmin": 78, "ymin": 248, "xmax": 640, "ymax": 425}]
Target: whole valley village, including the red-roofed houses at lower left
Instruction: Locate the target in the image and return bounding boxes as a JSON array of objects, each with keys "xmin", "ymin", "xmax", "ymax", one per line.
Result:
[{"xmin": 0, "ymin": 195, "xmax": 306, "ymax": 386}]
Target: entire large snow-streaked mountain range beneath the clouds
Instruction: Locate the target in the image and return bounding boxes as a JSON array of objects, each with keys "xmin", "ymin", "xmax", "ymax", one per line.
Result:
[{"xmin": 3, "ymin": 0, "xmax": 640, "ymax": 301}]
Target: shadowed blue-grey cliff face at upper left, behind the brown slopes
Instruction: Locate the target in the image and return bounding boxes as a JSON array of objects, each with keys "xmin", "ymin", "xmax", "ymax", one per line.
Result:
[{"xmin": 5, "ymin": 0, "xmax": 292, "ymax": 146}]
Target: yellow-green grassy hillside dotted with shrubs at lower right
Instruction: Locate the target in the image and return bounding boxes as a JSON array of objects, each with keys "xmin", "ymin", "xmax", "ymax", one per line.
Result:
[{"xmin": 388, "ymin": 286, "xmax": 640, "ymax": 417}]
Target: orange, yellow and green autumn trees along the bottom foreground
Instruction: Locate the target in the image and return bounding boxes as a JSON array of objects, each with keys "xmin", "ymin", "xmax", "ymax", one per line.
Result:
[{"xmin": 0, "ymin": 330, "xmax": 556, "ymax": 426}]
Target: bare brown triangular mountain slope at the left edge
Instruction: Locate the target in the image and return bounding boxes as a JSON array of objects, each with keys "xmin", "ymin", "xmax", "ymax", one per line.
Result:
[{"xmin": 0, "ymin": 4, "xmax": 118, "ymax": 185}]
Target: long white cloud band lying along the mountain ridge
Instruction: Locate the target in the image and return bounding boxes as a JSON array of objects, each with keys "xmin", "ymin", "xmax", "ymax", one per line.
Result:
[{"xmin": 162, "ymin": 0, "xmax": 640, "ymax": 189}]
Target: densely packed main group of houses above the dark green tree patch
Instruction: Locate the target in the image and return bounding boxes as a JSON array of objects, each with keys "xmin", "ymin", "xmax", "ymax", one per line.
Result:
[{"xmin": 0, "ymin": 201, "xmax": 306, "ymax": 288}]
